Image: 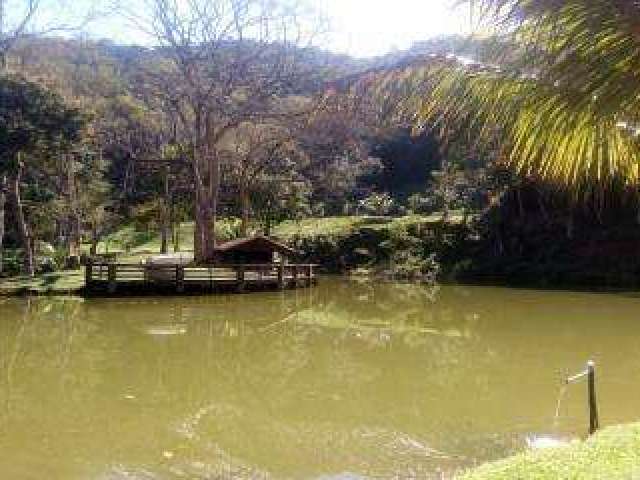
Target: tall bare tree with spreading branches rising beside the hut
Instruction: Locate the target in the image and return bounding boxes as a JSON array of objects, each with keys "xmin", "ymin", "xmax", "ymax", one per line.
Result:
[{"xmin": 124, "ymin": 0, "xmax": 319, "ymax": 262}]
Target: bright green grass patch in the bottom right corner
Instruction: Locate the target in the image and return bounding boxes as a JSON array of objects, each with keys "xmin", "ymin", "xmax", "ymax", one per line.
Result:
[{"xmin": 458, "ymin": 423, "xmax": 640, "ymax": 480}]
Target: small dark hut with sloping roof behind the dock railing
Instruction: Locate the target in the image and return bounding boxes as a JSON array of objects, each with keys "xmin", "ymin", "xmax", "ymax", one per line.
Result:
[{"xmin": 214, "ymin": 236, "xmax": 297, "ymax": 265}]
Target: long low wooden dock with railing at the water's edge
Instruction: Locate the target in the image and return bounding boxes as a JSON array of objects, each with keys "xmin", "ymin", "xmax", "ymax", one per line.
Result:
[{"xmin": 85, "ymin": 263, "xmax": 317, "ymax": 295}]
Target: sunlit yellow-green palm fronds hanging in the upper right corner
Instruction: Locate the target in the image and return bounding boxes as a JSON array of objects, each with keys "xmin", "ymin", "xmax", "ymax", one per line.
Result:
[{"xmin": 378, "ymin": 0, "xmax": 640, "ymax": 190}]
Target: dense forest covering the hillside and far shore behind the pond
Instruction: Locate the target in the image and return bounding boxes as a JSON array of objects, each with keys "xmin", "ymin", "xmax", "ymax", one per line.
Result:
[{"xmin": 0, "ymin": 0, "xmax": 640, "ymax": 284}]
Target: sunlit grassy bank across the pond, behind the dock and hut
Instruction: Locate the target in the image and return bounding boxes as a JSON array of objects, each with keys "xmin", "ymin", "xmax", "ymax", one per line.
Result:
[{"xmin": 0, "ymin": 215, "xmax": 463, "ymax": 295}]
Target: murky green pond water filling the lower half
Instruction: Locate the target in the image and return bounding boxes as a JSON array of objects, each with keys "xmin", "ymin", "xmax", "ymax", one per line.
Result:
[{"xmin": 0, "ymin": 279, "xmax": 640, "ymax": 480}]
